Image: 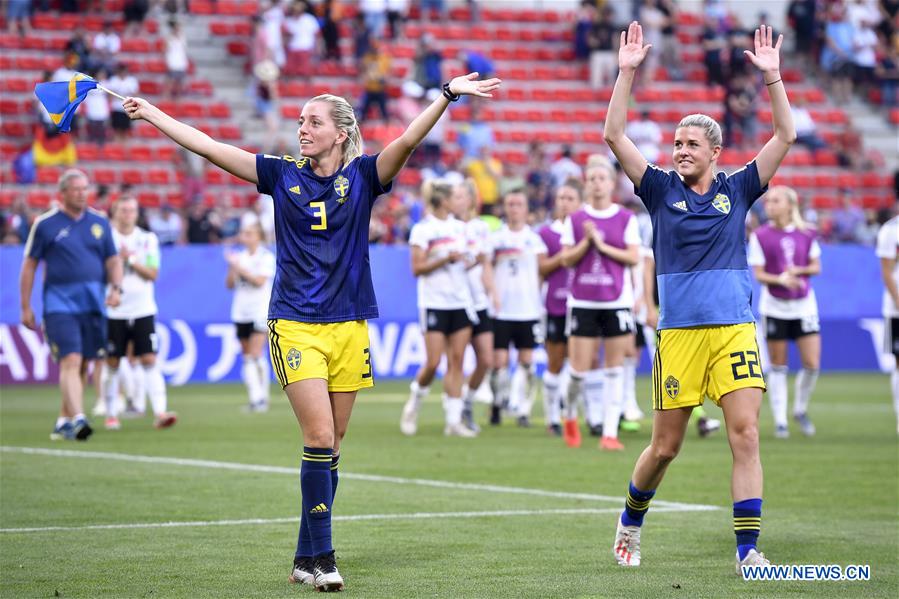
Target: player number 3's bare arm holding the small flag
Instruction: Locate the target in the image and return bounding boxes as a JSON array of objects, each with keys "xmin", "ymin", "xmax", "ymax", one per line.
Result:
[{"xmin": 123, "ymin": 98, "xmax": 259, "ymax": 183}]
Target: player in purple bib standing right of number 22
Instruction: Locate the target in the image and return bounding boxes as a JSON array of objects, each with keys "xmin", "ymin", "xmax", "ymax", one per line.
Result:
[{"xmin": 747, "ymin": 186, "xmax": 821, "ymax": 439}]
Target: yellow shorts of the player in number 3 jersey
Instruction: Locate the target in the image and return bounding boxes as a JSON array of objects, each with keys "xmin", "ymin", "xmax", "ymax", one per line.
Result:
[{"xmin": 268, "ymin": 320, "xmax": 374, "ymax": 391}]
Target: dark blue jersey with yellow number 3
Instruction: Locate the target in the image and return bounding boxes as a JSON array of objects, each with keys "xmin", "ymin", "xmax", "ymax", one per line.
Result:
[{"xmin": 256, "ymin": 154, "xmax": 392, "ymax": 323}]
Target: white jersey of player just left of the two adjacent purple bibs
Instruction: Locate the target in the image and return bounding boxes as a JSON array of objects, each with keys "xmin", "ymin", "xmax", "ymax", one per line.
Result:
[{"xmin": 490, "ymin": 225, "xmax": 548, "ymax": 321}]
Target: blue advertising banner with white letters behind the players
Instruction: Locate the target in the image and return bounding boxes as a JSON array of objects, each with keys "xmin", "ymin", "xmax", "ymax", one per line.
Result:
[{"xmin": 0, "ymin": 246, "xmax": 892, "ymax": 385}]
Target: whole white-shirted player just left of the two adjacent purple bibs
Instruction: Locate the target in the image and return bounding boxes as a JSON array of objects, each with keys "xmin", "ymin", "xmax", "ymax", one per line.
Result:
[{"xmin": 490, "ymin": 189, "xmax": 547, "ymax": 427}]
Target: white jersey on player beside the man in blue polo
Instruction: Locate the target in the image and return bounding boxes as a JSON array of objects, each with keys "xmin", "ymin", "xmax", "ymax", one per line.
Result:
[{"xmin": 106, "ymin": 227, "xmax": 159, "ymax": 320}]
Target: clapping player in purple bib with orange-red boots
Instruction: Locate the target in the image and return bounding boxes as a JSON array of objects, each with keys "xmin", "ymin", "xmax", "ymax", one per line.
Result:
[{"xmin": 562, "ymin": 157, "xmax": 640, "ymax": 451}]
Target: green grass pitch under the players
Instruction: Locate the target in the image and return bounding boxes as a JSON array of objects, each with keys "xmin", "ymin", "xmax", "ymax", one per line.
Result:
[{"xmin": 0, "ymin": 374, "xmax": 899, "ymax": 599}]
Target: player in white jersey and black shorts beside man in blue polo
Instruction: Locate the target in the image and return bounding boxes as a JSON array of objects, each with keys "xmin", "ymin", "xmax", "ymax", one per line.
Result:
[{"xmin": 104, "ymin": 196, "xmax": 177, "ymax": 430}]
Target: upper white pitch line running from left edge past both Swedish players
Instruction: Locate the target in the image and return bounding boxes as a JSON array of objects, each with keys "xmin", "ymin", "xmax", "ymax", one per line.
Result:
[{"xmin": 0, "ymin": 445, "xmax": 721, "ymax": 511}]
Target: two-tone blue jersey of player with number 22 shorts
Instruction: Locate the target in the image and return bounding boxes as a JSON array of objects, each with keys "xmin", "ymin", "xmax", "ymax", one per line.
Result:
[{"xmin": 635, "ymin": 161, "xmax": 767, "ymax": 329}]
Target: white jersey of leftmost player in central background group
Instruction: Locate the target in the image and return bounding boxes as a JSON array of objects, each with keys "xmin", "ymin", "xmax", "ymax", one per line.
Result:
[{"xmin": 409, "ymin": 214, "xmax": 471, "ymax": 310}]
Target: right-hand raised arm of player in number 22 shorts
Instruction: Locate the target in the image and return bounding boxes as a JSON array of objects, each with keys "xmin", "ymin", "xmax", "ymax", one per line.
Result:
[{"xmin": 744, "ymin": 25, "xmax": 796, "ymax": 187}]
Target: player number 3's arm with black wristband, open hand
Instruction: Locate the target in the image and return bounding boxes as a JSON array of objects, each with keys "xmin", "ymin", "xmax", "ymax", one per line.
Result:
[{"xmin": 372, "ymin": 73, "xmax": 502, "ymax": 185}]
